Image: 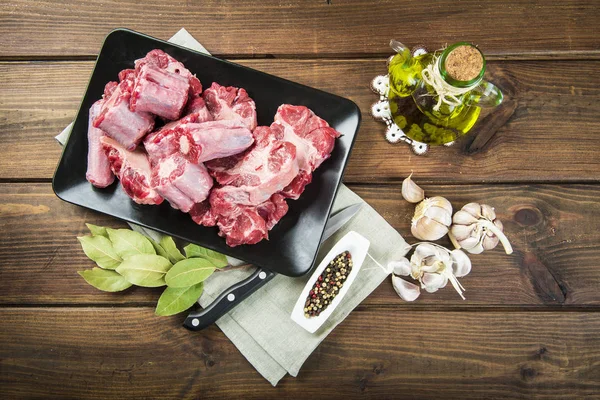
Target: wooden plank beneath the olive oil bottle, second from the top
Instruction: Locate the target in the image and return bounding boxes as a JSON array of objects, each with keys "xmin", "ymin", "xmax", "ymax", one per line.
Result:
[{"xmin": 0, "ymin": 59, "xmax": 600, "ymax": 183}]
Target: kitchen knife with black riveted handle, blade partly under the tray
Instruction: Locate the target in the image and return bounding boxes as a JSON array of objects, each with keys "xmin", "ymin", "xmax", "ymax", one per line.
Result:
[{"xmin": 183, "ymin": 203, "xmax": 362, "ymax": 331}]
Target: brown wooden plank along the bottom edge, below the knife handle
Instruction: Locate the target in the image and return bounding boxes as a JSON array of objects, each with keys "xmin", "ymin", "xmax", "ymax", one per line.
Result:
[{"xmin": 0, "ymin": 308, "xmax": 600, "ymax": 399}]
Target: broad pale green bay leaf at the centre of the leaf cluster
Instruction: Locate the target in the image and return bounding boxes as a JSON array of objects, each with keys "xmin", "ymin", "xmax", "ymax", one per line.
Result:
[{"xmin": 116, "ymin": 254, "xmax": 172, "ymax": 287}]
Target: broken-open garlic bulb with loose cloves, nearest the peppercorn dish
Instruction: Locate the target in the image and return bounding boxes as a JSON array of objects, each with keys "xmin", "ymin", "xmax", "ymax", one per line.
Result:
[{"xmin": 388, "ymin": 243, "xmax": 471, "ymax": 301}]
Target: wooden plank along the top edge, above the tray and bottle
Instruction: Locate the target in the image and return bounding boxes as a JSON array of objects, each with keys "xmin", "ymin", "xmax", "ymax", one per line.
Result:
[{"xmin": 0, "ymin": 0, "xmax": 600, "ymax": 58}]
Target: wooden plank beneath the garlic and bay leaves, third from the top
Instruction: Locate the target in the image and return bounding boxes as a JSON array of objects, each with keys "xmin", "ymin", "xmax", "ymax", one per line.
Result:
[{"xmin": 0, "ymin": 183, "xmax": 600, "ymax": 309}]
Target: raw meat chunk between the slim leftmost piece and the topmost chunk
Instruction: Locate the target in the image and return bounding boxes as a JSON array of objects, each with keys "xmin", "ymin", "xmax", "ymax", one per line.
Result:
[{"xmin": 93, "ymin": 74, "xmax": 154, "ymax": 150}]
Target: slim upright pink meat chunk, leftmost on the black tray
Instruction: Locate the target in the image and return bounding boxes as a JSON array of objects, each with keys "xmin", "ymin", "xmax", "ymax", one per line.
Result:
[{"xmin": 85, "ymin": 100, "xmax": 115, "ymax": 188}]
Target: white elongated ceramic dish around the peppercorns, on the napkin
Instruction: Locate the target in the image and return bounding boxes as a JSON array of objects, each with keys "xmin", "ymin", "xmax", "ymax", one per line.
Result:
[{"xmin": 292, "ymin": 231, "xmax": 371, "ymax": 333}]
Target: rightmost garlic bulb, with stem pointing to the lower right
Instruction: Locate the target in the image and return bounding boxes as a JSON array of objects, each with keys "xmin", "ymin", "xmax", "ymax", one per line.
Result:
[{"xmin": 448, "ymin": 203, "xmax": 513, "ymax": 254}]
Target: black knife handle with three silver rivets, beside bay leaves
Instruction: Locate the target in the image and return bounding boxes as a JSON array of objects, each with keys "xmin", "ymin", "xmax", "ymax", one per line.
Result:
[{"xmin": 183, "ymin": 268, "xmax": 277, "ymax": 331}]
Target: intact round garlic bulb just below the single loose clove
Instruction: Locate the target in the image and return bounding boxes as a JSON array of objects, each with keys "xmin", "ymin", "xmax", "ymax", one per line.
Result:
[{"xmin": 410, "ymin": 197, "xmax": 452, "ymax": 240}]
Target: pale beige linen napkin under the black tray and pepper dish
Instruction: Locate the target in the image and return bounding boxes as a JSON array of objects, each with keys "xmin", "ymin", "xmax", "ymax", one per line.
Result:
[{"xmin": 56, "ymin": 28, "xmax": 408, "ymax": 386}]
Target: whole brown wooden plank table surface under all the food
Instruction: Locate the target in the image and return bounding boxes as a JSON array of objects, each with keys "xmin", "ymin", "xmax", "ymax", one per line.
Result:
[{"xmin": 0, "ymin": 0, "xmax": 600, "ymax": 399}]
